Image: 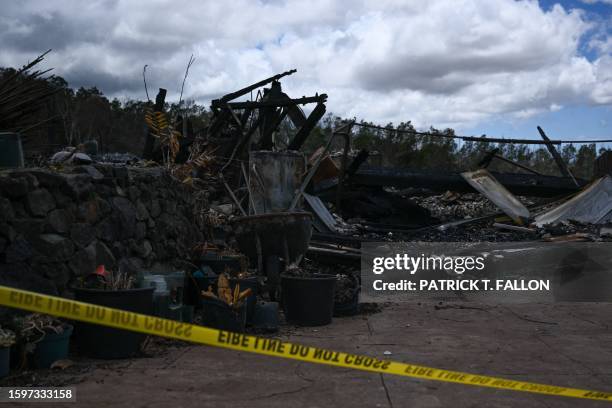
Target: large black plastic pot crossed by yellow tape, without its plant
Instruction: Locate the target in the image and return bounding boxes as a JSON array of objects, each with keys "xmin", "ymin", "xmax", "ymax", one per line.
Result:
[{"xmin": 74, "ymin": 287, "xmax": 155, "ymax": 359}]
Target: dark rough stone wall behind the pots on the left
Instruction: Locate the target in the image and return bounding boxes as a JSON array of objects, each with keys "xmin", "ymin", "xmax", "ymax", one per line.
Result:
[{"xmin": 0, "ymin": 165, "xmax": 202, "ymax": 295}]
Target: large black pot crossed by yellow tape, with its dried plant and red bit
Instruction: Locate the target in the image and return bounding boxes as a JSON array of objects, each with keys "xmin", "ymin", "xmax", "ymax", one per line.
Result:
[{"xmin": 73, "ymin": 265, "xmax": 155, "ymax": 359}]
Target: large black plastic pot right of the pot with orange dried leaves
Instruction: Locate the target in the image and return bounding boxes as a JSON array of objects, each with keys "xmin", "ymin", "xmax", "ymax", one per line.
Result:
[{"xmin": 281, "ymin": 274, "xmax": 336, "ymax": 326}]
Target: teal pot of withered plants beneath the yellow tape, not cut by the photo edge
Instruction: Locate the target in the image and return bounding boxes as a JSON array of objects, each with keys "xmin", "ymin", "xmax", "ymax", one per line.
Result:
[{"xmin": 19, "ymin": 313, "xmax": 72, "ymax": 368}]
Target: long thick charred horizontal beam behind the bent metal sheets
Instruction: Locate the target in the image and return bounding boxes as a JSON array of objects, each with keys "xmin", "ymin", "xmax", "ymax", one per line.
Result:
[{"xmin": 350, "ymin": 168, "xmax": 587, "ymax": 197}]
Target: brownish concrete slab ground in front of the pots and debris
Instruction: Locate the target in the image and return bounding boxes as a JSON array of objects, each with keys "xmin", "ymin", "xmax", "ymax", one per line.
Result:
[{"xmin": 2, "ymin": 301, "xmax": 612, "ymax": 408}]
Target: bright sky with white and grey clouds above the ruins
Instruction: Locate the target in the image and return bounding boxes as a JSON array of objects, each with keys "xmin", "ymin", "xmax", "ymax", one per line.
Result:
[{"xmin": 0, "ymin": 0, "xmax": 612, "ymax": 138}]
